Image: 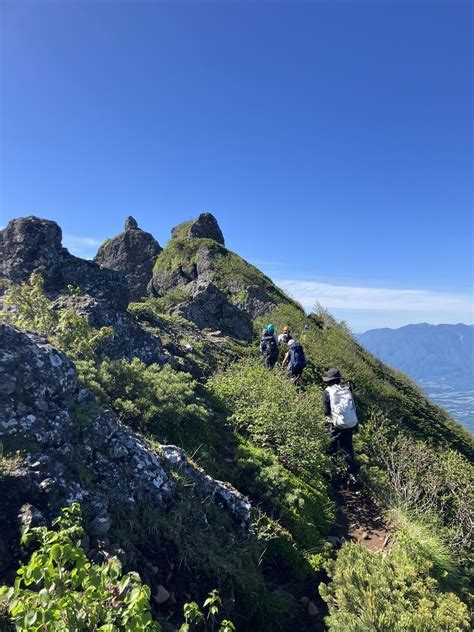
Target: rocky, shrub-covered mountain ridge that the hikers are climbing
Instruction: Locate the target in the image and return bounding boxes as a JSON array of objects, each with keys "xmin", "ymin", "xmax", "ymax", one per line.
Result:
[{"xmin": 0, "ymin": 214, "xmax": 474, "ymax": 632}]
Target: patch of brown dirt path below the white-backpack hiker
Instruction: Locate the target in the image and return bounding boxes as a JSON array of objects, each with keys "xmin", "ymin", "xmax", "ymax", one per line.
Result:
[{"xmin": 333, "ymin": 487, "xmax": 393, "ymax": 553}]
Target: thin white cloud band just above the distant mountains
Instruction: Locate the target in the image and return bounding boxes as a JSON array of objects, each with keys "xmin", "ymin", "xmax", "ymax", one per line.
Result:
[{"xmin": 278, "ymin": 279, "xmax": 473, "ymax": 314}]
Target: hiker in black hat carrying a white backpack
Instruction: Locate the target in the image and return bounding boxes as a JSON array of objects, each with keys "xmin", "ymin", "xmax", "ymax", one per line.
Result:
[{"xmin": 323, "ymin": 369, "xmax": 358, "ymax": 481}]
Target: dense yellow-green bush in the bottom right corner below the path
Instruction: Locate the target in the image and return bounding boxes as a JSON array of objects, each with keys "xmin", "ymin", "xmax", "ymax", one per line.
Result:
[{"xmin": 319, "ymin": 543, "xmax": 470, "ymax": 632}]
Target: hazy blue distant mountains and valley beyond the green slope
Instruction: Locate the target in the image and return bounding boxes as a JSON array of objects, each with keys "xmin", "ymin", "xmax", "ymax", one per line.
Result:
[{"xmin": 355, "ymin": 323, "xmax": 474, "ymax": 430}]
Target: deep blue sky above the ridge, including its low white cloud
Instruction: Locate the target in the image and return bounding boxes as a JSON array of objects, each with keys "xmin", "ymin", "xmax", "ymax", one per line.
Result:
[{"xmin": 0, "ymin": 0, "xmax": 473, "ymax": 331}]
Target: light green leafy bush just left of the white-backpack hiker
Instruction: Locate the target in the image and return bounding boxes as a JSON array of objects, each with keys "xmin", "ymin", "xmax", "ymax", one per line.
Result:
[{"xmin": 208, "ymin": 361, "xmax": 329, "ymax": 482}]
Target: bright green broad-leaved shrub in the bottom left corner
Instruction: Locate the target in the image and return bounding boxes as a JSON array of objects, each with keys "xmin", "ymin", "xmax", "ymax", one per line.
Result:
[{"xmin": 0, "ymin": 503, "xmax": 160, "ymax": 632}]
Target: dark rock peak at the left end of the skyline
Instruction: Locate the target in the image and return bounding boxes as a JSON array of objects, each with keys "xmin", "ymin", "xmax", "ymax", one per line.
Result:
[{"xmin": 0, "ymin": 216, "xmax": 128, "ymax": 310}]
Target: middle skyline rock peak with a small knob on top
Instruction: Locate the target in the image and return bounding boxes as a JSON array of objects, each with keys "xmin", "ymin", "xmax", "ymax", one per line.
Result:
[{"xmin": 94, "ymin": 217, "xmax": 163, "ymax": 301}]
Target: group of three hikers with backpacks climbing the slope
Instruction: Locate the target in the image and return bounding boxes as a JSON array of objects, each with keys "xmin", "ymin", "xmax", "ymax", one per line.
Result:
[{"xmin": 260, "ymin": 324, "xmax": 358, "ymax": 483}]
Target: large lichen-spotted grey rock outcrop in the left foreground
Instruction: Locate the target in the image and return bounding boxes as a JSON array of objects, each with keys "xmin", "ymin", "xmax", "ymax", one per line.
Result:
[{"xmin": 0, "ymin": 324, "xmax": 250, "ymax": 576}]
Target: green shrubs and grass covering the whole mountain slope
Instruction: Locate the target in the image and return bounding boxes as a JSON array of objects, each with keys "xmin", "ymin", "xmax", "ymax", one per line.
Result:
[{"xmin": 0, "ymin": 249, "xmax": 473, "ymax": 632}]
